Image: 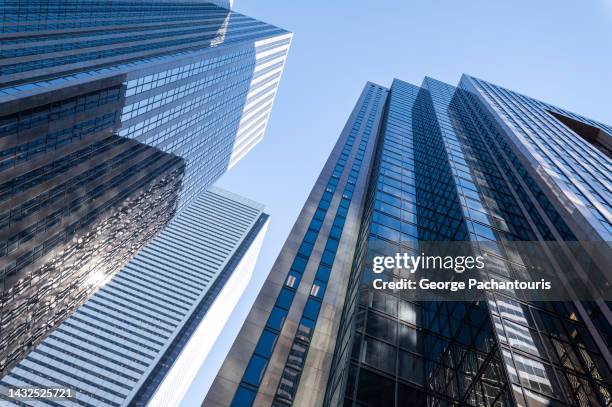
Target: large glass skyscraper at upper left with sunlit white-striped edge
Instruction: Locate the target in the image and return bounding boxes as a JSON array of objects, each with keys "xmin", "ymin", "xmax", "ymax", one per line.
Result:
[{"xmin": 0, "ymin": 0, "xmax": 291, "ymax": 376}]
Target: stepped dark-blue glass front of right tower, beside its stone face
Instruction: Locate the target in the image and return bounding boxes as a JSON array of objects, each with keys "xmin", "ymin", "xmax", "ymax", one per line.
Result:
[{"xmin": 326, "ymin": 77, "xmax": 612, "ymax": 406}]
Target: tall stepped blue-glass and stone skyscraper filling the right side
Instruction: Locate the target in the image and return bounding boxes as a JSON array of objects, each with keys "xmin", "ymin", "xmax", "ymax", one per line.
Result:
[{"xmin": 203, "ymin": 75, "xmax": 612, "ymax": 407}]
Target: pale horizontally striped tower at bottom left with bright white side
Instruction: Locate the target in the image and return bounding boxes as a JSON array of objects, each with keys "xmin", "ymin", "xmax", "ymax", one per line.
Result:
[{"xmin": 0, "ymin": 187, "xmax": 269, "ymax": 407}]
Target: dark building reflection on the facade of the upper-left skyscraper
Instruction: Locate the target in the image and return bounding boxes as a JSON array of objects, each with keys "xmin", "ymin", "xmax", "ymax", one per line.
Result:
[{"xmin": 0, "ymin": 77, "xmax": 185, "ymax": 372}]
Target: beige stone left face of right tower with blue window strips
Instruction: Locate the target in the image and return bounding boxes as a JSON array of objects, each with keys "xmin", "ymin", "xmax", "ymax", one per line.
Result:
[{"xmin": 204, "ymin": 84, "xmax": 387, "ymax": 406}]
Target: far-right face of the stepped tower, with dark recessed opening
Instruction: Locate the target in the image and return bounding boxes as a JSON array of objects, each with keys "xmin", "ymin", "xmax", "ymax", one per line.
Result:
[{"xmin": 460, "ymin": 76, "xmax": 612, "ymax": 242}]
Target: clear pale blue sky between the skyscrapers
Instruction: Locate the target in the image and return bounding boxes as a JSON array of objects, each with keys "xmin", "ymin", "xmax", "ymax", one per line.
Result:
[{"xmin": 184, "ymin": 0, "xmax": 612, "ymax": 404}]
